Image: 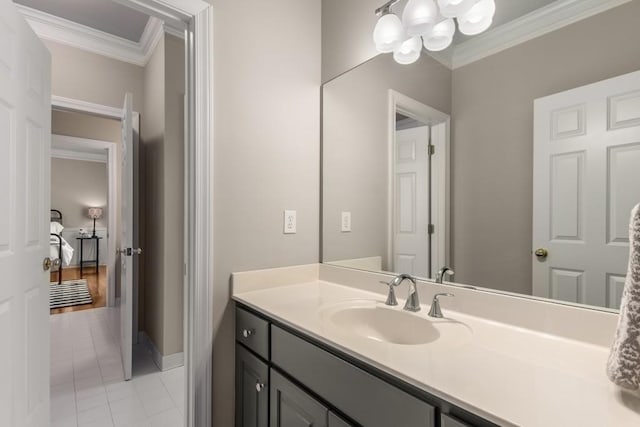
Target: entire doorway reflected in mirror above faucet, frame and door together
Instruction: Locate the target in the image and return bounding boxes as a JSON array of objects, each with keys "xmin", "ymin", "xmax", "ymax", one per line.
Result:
[{"xmin": 387, "ymin": 90, "xmax": 449, "ymax": 278}]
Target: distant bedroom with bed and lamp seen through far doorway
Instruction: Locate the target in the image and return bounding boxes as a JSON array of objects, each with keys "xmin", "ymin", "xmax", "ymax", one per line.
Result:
[{"xmin": 50, "ymin": 108, "xmax": 121, "ymax": 315}]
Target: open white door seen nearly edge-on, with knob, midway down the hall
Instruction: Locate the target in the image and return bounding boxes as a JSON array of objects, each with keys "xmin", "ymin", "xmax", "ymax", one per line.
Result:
[{"xmin": 119, "ymin": 93, "xmax": 134, "ymax": 380}]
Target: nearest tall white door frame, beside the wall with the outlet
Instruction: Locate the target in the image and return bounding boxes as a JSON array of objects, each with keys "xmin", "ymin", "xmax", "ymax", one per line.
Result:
[{"xmin": 114, "ymin": 0, "xmax": 214, "ymax": 427}]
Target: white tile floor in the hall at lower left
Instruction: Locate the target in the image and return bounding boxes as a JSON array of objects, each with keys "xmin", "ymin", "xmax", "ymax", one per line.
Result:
[{"xmin": 50, "ymin": 308, "xmax": 184, "ymax": 427}]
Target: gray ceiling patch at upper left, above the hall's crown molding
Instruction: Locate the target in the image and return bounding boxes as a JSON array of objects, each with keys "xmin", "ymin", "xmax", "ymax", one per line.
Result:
[{"xmin": 14, "ymin": 0, "xmax": 149, "ymax": 42}]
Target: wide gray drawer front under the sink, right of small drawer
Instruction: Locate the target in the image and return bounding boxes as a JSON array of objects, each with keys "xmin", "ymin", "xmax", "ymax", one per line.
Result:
[{"xmin": 271, "ymin": 325, "xmax": 435, "ymax": 427}]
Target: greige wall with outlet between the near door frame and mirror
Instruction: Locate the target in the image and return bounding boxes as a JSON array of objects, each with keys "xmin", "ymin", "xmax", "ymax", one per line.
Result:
[{"xmin": 211, "ymin": 0, "xmax": 321, "ymax": 426}]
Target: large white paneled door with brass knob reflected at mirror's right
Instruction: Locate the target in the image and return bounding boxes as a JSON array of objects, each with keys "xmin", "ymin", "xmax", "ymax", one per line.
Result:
[{"xmin": 532, "ymin": 72, "xmax": 640, "ymax": 308}]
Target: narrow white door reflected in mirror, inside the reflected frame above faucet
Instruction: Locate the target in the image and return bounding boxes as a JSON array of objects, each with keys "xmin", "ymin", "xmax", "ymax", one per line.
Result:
[{"xmin": 393, "ymin": 126, "xmax": 431, "ymax": 277}]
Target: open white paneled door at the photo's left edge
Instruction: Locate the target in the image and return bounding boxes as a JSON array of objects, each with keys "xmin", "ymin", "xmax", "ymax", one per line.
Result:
[{"xmin": 0, "ymin": 0, "xmax": 51, "ymax": 427}]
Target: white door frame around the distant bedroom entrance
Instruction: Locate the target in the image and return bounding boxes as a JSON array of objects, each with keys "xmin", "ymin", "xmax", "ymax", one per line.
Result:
[{"xmin": 51, "ymin": 134, "xmax": 118, "ymax": 307}]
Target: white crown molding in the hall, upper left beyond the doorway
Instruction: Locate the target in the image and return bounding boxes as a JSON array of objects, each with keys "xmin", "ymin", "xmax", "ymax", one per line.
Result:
[{"xmin": 15, "ymin": 4, "xmax": 184, "ymax": 67}]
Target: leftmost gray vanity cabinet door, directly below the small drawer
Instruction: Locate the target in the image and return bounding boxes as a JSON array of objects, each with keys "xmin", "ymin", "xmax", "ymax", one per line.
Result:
[{"xmin": 236, "ymin": 344, "xmax": 269, "ymax": 427}]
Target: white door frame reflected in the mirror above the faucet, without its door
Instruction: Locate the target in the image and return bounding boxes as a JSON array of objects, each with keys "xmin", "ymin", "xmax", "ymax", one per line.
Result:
[{"xmin": 387, "ymin": 89, "xmax": 451, "ymax": 273}]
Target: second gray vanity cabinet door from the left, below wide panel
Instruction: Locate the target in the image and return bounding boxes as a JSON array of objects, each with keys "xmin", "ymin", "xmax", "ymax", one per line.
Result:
[{"xmin": 270, "ymin": 369, "xmax": 329, "ymax": 427}]
